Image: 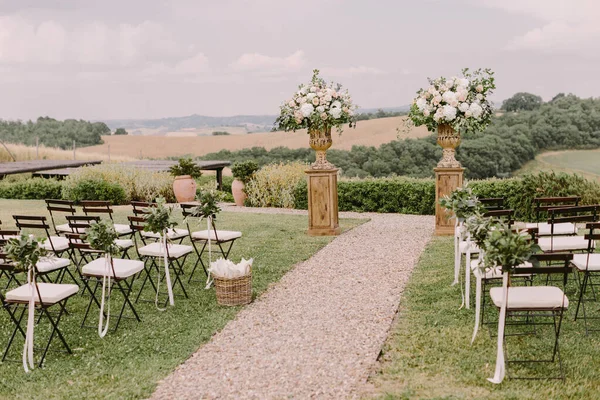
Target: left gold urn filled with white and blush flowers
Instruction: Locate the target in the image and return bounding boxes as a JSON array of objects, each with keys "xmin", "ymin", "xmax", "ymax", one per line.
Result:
[{"xmin": 274, "ymin": 69, "xmax": 357, "ymax": 169}]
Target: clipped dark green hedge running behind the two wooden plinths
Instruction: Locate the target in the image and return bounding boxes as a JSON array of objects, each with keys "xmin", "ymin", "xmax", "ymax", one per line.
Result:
[{"xmin": 295, "ymin": 172, "xmax": 600, "ymax": 221}]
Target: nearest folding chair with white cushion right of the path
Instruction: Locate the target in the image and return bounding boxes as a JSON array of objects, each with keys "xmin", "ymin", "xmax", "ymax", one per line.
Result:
[{"xmin": 490, "ymin": 253, "xmax": 573, "ymax": 380}]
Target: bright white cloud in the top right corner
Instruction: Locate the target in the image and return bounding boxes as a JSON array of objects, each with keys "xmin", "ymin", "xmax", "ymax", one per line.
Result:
[{"xmin": 473, "ymin": 0, "xmax": 600, "ymax": 51}]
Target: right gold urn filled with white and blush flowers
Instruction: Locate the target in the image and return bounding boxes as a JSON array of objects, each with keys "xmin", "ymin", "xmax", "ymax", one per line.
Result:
[{"xmin": 407, "ymin": 68, "xmax": 496, "ymax": 168}]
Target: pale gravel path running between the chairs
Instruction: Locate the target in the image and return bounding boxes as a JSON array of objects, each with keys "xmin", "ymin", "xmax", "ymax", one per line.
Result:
[{"xmin": 152, "ymin": 214, "xmax": 434, "ymax": 399}]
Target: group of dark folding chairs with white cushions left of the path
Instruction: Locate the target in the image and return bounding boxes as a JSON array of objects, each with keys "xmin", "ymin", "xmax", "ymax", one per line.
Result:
[{"xmin": 0, "ymin": 200, "xmax": 242, "ymax": 366}]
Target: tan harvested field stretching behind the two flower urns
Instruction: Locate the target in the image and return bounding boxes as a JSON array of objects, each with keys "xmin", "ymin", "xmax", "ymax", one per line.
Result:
[{"xmin": 79, "ymin": 117, "xmax": 428, "ymax": 158}]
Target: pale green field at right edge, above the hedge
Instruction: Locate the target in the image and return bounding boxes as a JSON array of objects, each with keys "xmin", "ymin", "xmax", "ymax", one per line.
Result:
[{"xmin": 516, "ymin": 149, "xmax": 600, "ymax": 181}]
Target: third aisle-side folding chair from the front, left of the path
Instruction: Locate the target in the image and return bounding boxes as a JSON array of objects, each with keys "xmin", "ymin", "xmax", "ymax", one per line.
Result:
[{"xmin": 127, "ymin": 216, "xmax": 194, "ymax": 304}]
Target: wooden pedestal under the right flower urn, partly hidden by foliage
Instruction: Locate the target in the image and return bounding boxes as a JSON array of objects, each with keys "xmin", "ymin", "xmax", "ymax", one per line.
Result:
[{"xmin": 433, "ymin": 168, "xmax": 465, "ymax": 236}]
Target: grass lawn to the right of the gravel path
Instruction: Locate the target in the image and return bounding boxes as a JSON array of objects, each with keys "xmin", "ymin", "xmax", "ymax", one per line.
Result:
[{"xmin": 370, "ymin": 237, "xmax": 600, "ymax": 400}]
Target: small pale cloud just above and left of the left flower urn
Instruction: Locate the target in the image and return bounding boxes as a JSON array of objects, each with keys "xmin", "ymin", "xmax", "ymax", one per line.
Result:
[{"xmin": 230, "ymin": 50, "xmax": 306, "ymax": 75}]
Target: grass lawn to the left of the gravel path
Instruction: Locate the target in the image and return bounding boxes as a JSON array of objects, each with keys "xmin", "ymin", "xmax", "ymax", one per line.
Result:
[{"xmin": 0, "ymin": 200, "xmax": 366, "ymax": 399}]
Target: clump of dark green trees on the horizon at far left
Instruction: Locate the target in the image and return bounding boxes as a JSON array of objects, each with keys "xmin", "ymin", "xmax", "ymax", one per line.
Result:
[{"xmin": 0, "ymin": 117, "xmax": 110, "ymax": 150}]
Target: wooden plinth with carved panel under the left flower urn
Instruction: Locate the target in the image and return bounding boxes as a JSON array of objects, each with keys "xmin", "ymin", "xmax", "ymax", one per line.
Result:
[{"xmin": 306, "ymin": 169, "xmax": 341, "ymax": 236}]
